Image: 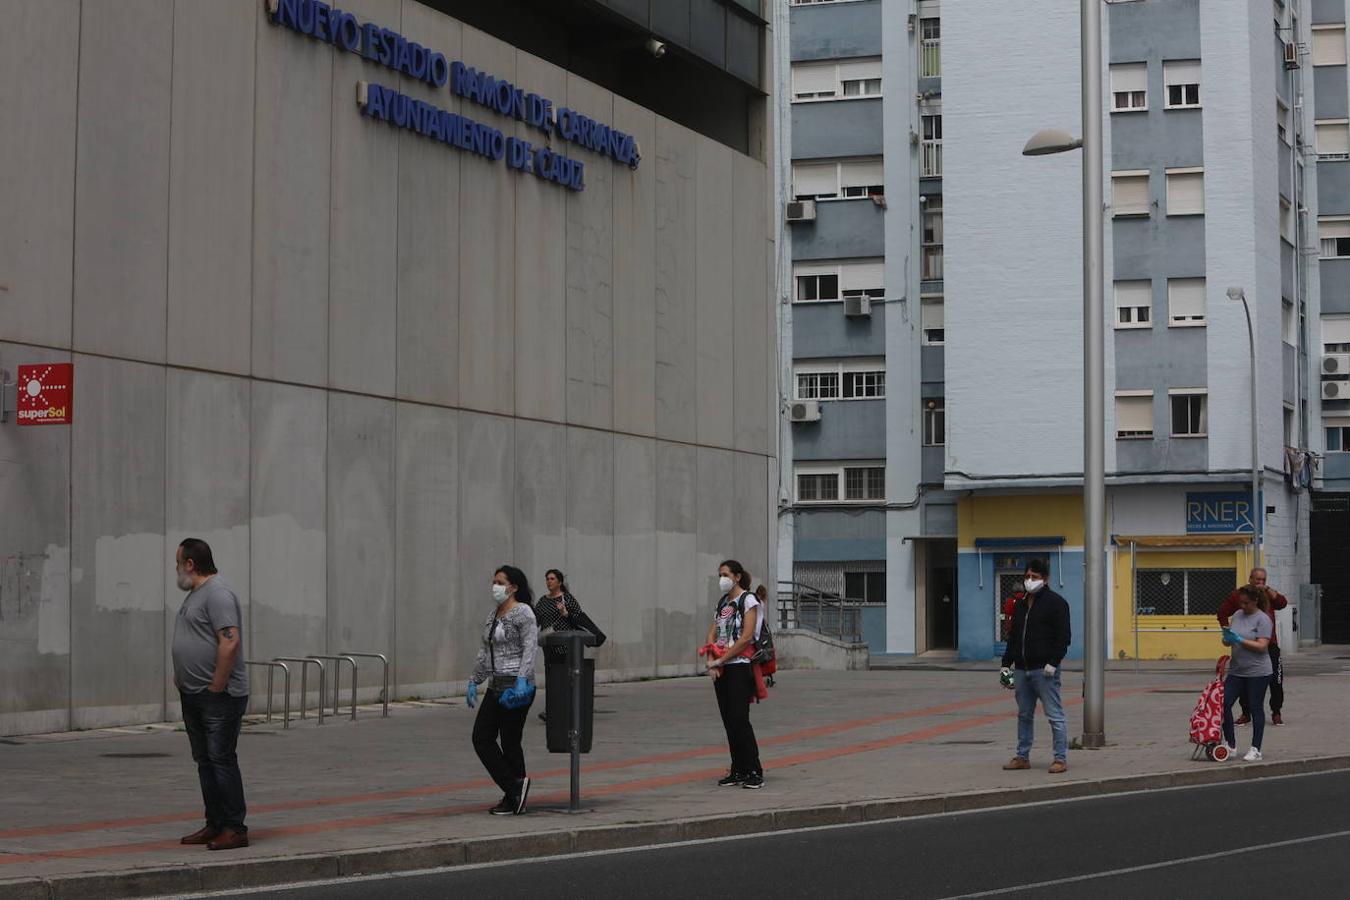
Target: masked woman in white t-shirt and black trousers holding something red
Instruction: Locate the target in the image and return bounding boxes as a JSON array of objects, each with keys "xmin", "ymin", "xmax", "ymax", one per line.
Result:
[{"xmin": 699, "ymin": 560, "xmax": 764, "ymax": 789}]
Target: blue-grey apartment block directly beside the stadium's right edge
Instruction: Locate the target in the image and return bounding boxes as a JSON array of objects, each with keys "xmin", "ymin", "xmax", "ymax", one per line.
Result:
[{"xmin": 779, "ymin": 0, "xmax": 959, "ymax": 653}]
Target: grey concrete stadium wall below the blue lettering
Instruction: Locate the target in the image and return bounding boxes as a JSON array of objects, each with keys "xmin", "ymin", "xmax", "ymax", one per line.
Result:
[{"xmin": 0, "ymin": 0, "xmax": 776, "ymax": 734}]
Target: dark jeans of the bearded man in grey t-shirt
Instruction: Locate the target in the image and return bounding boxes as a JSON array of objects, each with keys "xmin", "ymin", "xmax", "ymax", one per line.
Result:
[{"xmin": 178, "ymin": 691, "xmax": 248, "ymax": 831}]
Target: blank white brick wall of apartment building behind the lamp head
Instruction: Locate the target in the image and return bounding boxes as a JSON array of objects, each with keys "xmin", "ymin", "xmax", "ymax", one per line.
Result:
[{"xmin": 942, "ymin": 0, "xmax": 1083, "ymax": 487}]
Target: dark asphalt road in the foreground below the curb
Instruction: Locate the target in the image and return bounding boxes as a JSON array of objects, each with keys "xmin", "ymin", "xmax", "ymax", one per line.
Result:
[{"xmin": 202, "ymin": 773, "xmax": 1350, "ymax": 900}]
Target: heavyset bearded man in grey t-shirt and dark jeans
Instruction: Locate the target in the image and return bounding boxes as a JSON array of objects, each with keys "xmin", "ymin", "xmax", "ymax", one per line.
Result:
[{"xmin": 173, "ymin": 537, "xmax": 248, "ymax": 850}]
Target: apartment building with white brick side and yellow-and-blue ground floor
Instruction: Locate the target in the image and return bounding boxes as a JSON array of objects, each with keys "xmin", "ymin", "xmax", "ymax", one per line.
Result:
[{"xmin": 944, "ymin": 0, "xmax": 1317, "ymax": 658}]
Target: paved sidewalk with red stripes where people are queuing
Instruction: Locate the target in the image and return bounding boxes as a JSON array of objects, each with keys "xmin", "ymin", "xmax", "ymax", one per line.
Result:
[{"xmin": 0, "ymin": 650, "xmax": 1350, "ymax": 899}]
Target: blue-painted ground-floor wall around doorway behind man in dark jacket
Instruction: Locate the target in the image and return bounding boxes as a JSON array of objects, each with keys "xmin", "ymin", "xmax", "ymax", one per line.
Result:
[{"xmin": 956, "ymin": 549, "xmax": 1083, "ymax": 660}]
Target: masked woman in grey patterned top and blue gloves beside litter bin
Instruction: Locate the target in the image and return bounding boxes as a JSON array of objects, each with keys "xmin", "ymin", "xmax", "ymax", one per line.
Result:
[{"xmin": 464, "ymin": 565, "xmax": 539, "ymax": 815}]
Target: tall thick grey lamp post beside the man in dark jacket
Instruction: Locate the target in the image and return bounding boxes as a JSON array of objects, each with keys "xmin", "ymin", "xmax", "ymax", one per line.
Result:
[{"xmin": 1022, "ymin": 0, "xmax": 1106, "ymax": 749}]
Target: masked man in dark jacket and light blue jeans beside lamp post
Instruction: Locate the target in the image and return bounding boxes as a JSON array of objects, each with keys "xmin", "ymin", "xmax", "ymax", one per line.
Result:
[{"xmin": 999, "ymin": 560, "xmax": 1071, "ymax": 775}]
